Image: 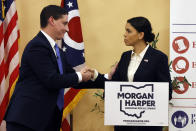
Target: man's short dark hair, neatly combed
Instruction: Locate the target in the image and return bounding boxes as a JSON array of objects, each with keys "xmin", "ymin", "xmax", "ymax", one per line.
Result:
[{"xmin": 40, "ymin": 5, "xmax": 68, "ymax": 28}]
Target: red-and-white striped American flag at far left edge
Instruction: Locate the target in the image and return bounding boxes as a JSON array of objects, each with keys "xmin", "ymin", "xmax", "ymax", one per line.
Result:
[{"xmin": 0, "ymin": 0, "xmax": 19, "ymax": 125}]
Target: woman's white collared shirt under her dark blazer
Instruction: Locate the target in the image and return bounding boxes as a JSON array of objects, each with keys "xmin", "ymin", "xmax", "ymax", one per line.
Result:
[{"xmin": 127, "ymin": 45, "xmax": 149, "ymax": 82}]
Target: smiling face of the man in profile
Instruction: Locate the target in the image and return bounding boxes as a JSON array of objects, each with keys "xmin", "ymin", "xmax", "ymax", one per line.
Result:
[{"xmin": 53, "ymin": 15, "xmax": 69, "ymax": 40}]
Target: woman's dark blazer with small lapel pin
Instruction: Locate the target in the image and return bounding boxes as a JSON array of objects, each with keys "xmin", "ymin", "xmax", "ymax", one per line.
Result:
[{"xmin": 97, "ymin": 46, "xmax": 172, "ymax": 99}]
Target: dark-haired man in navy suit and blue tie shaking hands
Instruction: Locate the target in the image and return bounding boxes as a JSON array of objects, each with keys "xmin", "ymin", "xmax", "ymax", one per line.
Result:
[{"xmin": 5, "ymin": 5, "xmax": 92, "ymax": 131}]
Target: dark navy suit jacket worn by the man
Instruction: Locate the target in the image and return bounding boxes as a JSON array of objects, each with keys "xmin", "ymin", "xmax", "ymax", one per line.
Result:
[{"xmin": 5, "ymin": 32, "xmax": 99, "ymax": 131}]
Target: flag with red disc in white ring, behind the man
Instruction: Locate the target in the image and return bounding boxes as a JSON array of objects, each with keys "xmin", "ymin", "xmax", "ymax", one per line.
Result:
[{"xmin": 61, "ymin": 0, "xmax": 86, "ymax": 131}]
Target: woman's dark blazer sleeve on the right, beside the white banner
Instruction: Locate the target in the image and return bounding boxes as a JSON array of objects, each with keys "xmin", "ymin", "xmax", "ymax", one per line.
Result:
[{"xmin": 157, "ymin": 55, "xmax": 172, "ymax": 100}]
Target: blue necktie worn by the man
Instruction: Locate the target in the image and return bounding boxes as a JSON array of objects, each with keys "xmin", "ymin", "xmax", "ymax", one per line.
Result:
[{"xmin": 54, "ymin": 44, "xmax": 64, "ymax": 111}]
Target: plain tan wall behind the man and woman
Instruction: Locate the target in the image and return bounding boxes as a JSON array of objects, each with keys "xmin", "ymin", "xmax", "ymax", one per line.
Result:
[{"xmin": 16, "ymin": 0, "xmax": 169, "ymax": 131}]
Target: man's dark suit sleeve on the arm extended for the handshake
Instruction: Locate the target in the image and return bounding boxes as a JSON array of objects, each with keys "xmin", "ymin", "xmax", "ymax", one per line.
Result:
[{"xmin": 27, "ymin": 43, "xmax": 78, "ymax": 89}]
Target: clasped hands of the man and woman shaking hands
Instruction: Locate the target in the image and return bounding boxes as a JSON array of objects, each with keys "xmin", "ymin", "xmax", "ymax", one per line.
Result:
[{"xmin": 80, "ymin": 66, "xmax": 95, "ymax": 82}]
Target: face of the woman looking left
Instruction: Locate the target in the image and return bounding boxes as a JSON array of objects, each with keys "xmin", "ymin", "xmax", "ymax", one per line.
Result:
[{"xmin": 124, "ymin": 23, "xmax": 140, "ymax": 46}]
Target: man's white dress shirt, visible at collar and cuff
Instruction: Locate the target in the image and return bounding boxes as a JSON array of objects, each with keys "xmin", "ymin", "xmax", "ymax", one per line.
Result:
[{"xmin": 41, "ymin": 30, "xmax": 82, "ymax": 82}]
